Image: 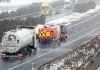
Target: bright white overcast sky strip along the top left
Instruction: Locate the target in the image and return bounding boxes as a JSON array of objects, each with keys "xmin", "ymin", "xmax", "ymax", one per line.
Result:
[{"xmin": 0, "ymin": 0, "xmax": 56, "ymax": 6}]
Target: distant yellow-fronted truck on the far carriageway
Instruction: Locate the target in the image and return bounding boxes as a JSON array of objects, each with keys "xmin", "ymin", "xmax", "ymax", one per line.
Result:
[{"xmin": 41, "ymin": 3, "xmax": 52, "ymax": 15}]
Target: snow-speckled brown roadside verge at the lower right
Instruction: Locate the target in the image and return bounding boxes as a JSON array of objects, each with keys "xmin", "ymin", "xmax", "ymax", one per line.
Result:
[{"xmin": 34, "ymin": 36, "xmax": 100, "ymax": 70}]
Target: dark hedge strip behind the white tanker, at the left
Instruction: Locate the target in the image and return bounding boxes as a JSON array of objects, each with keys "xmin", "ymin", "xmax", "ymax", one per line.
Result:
[{"xmin": 0, "ymin": 15, "xmax": 45, "ymax": 41}]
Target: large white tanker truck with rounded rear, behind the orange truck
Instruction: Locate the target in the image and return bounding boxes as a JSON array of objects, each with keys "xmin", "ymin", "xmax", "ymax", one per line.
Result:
[{"xmin": 1, "ymin": 26, "xmax": 37, "ymax": 59}]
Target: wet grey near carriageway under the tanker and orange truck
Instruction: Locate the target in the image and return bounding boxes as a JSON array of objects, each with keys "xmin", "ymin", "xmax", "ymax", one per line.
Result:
[{"xmin": 0, "ymin": 11, "xmax": 100, "ymax": 70}]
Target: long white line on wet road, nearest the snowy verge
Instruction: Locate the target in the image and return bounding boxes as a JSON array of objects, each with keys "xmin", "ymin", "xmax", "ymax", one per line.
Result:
[{"xmin": 8, "ymin": 22, "xmax": 100, "ymax": 70}]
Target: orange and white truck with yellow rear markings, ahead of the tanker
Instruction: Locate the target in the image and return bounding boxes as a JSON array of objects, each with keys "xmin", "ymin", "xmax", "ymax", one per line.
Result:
[{"xmin": 38, "ymin": 25, "xmax": 67, "ymax": 44}]
